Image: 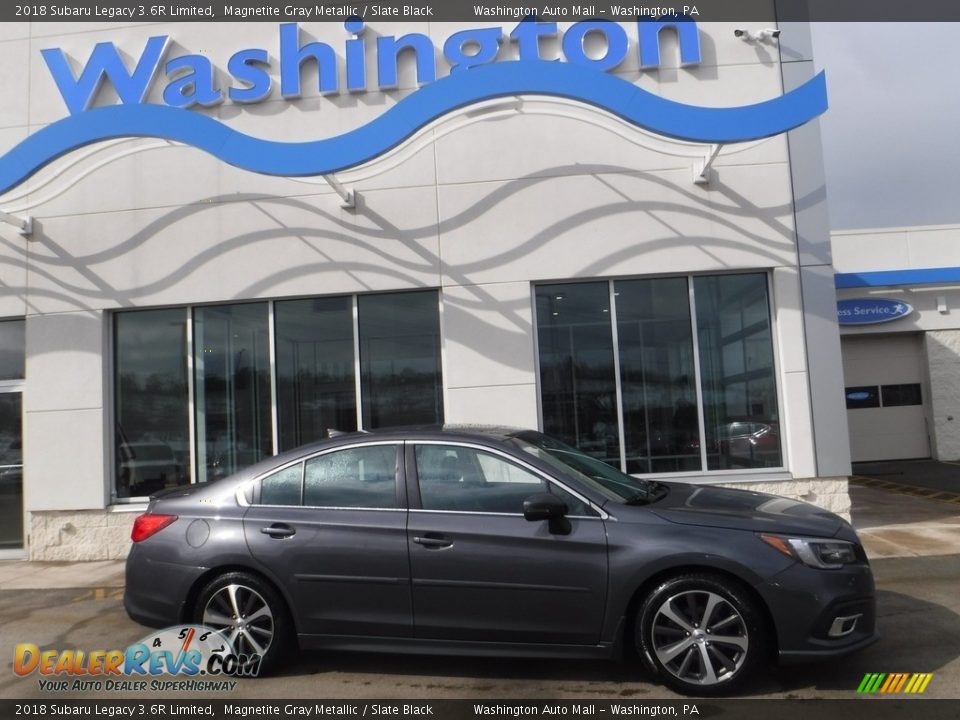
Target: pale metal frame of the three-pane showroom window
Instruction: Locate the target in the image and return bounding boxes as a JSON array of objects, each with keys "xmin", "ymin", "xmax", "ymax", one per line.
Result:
[{"xmin": 530, "ymin": 268, "xmax": 790, "ymax": 484}]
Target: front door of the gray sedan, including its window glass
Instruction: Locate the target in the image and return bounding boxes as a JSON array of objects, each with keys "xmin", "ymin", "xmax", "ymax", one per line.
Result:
[{"xmin": 406, "ymin": 442, "xmax": 607, "ymax": 645}]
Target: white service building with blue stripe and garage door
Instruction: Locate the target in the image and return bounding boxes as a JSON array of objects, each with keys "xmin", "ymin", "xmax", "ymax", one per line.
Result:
[{"xmin": 833, "ymin": 225, "xmax": 960, "ymax": 462}]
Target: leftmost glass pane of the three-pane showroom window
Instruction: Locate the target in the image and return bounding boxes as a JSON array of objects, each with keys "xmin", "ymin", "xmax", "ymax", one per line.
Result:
[{"xmin": 536, "ymin": 282, "xmax": 620, "ymax": 467}]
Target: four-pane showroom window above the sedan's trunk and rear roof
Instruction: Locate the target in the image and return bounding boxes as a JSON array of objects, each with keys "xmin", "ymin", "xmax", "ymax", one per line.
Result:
[{"xmin": 113, "ymin": 290, "xmax": 443, "ymax": 500}]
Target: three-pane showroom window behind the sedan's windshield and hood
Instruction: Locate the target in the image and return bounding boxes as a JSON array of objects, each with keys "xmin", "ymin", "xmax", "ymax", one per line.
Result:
[{"xmin": 536, "ymin": 273, "xmax": 782, "ymax": 473}]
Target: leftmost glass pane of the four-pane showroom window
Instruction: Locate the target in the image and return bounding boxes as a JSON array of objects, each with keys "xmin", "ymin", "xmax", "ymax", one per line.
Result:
[{"xmin": 114, "ymin": 309, "xmax": 190, "ymax": 498}]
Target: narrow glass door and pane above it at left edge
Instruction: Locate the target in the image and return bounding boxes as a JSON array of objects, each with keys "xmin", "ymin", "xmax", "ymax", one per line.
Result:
[{"xmin": 0, "ymin": 320, "xmax": 25, "ymax": 550}]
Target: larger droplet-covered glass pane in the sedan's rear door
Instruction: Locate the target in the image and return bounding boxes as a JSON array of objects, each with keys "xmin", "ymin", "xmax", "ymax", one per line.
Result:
[{"xmin": 303, "ymin": 445, "xmax": 397, "ymax": 508}]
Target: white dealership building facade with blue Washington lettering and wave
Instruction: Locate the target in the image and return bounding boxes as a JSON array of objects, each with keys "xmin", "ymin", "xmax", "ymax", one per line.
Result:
[{"xmin": 0, "ymin": 14, "xmax": 856, "ymax": 560}]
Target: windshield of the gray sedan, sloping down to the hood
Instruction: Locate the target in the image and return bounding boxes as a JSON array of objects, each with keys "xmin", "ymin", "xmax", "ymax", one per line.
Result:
[{"xmin": 512, "ymin": 432, "xmax": 660, "ymax": 503}]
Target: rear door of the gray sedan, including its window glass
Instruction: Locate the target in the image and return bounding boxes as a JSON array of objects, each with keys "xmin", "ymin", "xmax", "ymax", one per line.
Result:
[{"xmin": 243, "ymin": 443, "xmax": 413, "ymax": 637}]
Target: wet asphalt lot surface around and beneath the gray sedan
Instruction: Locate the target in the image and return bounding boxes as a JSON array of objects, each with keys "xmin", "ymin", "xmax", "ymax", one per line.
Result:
[{"xmin": 0, "ymin": 555, "xmax": 960, "ymax": 700}]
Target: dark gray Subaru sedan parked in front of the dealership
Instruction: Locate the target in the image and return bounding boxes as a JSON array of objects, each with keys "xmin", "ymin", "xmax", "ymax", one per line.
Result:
[{"xmin": 124, "ymin": 426, "xmax": 877, "ymax": 695}]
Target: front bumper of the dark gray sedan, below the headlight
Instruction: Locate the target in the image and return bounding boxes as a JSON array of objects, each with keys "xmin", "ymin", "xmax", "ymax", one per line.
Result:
[{"xmin": 757, "ymin": 563, "xmax": 880, "ymax": 663}]
